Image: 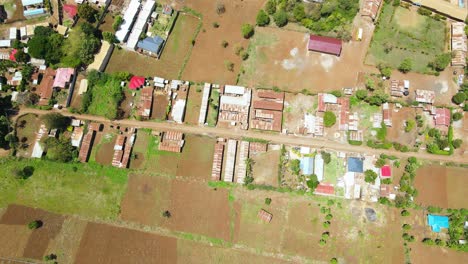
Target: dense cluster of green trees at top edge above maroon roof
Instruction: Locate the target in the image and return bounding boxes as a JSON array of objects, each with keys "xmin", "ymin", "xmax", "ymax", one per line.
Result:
[{"xmin": 264, "ymin": 0, "xmax": 359, "ymax": 40}]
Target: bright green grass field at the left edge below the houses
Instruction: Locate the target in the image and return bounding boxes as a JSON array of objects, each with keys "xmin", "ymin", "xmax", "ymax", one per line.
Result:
[{"xmin": 0, "ymin": 158, "xmax": 128, "ymax": 219}]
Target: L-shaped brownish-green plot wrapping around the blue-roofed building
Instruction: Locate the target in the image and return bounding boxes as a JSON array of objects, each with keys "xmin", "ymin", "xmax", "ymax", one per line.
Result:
[{"xmin": 106, "ymin": 14, "xmax": 200, "ymax": 77}]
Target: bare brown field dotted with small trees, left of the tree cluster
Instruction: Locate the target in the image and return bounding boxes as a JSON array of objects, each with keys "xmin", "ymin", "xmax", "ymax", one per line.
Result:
[{"xmin": 181, "ymin": 0, "xmax": 265, "ymax": 84}]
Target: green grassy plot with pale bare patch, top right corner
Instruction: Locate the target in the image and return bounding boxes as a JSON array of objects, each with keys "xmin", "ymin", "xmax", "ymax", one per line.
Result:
[{"xmin": 366, "ymin": 4, "xmax": 447, "ymax": 73}]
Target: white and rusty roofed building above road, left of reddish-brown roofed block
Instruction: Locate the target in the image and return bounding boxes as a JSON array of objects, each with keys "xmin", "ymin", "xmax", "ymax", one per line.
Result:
[{"xmin": 218, "ymin": 85, "xmax": 252, "ymax": 129}]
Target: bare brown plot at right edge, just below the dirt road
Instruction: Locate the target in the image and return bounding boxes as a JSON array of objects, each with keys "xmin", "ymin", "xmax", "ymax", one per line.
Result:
[{"xmin": 414, "ymin": 165, "xmax": 468, "ymax": 208}]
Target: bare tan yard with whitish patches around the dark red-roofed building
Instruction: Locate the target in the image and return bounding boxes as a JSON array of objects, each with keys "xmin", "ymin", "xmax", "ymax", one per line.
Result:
[{"xmin": 239, "ymin": 28, "xmax": 372, "ymax": 93}]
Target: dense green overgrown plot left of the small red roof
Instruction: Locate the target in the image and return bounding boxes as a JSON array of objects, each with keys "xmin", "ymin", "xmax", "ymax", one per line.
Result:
[{"xmin": 81, "ymin": 71, "xmax": 128, "ymax": 119}]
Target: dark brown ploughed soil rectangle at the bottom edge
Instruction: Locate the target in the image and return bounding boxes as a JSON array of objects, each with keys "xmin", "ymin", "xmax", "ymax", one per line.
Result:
[{"xmin": 75, "ymin": 223, "xmax": 177, "ymax": 263}]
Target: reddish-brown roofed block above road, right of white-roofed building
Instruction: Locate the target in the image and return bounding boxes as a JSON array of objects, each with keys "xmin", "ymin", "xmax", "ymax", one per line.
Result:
[{"xmin": 250, "ymin": 91, "xmax": 284, "ymax": 132}]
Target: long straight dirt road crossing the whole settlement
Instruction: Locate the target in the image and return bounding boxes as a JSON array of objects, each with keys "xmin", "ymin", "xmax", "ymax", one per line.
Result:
[{"xmin": 18, "ymin": 108, "xmax": 468, "ymax": 164}]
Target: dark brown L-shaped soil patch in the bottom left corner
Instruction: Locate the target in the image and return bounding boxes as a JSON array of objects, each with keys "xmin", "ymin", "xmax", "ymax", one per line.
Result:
[{"xmin": 0, "ymin": 205, "xmax": 64, "ymax": 259}]
